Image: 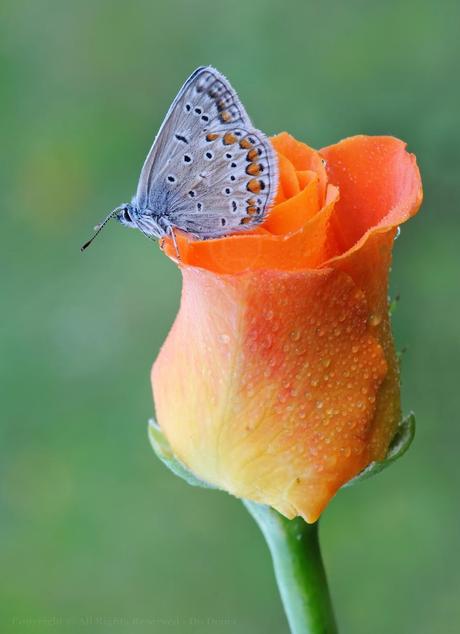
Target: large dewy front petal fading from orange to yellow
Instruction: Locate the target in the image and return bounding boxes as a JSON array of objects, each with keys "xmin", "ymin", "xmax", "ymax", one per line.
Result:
[{"xmin": 152, "ymin": 267, "xmax": 386, "ymax": 522}]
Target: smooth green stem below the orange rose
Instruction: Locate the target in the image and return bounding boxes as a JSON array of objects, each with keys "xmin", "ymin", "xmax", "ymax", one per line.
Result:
[{"xmin": 244, "ymin": 500, "xmax": 337, "ymax": 634}]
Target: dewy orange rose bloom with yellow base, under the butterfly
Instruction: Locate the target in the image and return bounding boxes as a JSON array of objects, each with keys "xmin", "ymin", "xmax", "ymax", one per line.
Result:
[{"xmin": 152, "ymin": 133, "xmax": 422, "ymax": 522}]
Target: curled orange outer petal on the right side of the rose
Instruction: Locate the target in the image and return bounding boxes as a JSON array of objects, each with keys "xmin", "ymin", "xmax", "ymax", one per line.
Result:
[{"xmin": 321, "ymin": 136, "xmax": 423, "ymax": 459}]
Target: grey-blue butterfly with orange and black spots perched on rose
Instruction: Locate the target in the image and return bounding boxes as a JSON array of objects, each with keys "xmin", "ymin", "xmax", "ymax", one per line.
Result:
[{"xmin": 81, "ymin": 66, "xmax": 278, "ymax": 252}]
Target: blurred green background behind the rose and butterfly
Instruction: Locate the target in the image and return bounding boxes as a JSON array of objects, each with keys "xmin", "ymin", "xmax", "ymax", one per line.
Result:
[{"xmin": 0, "ymin": 0, "xmax": 460, "ymax": 634}]
